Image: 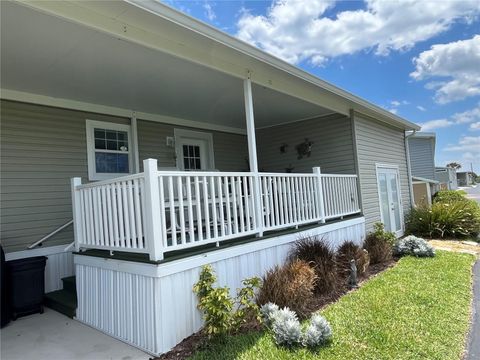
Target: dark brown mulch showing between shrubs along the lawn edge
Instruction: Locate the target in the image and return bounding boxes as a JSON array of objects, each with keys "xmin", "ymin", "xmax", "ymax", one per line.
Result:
[{"xmin": 155, "ymin": 259, "xmax": 397, "ymax": 360}]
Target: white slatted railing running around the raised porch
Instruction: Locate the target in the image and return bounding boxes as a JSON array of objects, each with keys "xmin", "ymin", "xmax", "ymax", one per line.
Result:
[{"xmin": 72, "ymin": 159, "xmax": 360, "ymax": 260}]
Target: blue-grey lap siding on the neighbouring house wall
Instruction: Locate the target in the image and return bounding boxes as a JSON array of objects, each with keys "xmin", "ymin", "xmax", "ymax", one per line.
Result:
[{"xmin": 408, "ymin": 137, "xmax": 435, "ymax": 180}]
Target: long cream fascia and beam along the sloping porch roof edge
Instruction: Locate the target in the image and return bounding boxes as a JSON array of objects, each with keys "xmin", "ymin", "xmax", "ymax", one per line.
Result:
[{"xmin": 15, "ymin": 0, "xmax": 420, "ymax": 130}]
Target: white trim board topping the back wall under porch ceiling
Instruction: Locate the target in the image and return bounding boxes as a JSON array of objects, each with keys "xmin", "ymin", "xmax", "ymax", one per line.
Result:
[{"xmin": 0, "ymin": 88, "xmax": 247, "ymax": 135}]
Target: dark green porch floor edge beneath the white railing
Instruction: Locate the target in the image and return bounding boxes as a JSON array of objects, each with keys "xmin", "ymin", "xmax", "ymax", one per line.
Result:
[{"xmin": 74, "ymin": 214, "xmax": 363, "ymax": 264}]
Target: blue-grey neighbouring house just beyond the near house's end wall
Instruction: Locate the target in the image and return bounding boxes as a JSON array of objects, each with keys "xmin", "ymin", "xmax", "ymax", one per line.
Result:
[{"xmin": 407, "ymin": 132, "xmax": 439, "ymax": 206}]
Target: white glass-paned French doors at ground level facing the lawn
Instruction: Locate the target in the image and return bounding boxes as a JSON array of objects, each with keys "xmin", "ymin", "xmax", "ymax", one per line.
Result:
[{"xmin": 377, "ymin": 166, "xmax": 403, "ymax": 236}]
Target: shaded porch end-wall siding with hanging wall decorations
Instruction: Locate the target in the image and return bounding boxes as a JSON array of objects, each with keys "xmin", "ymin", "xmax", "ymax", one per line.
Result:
[{"xmin": 257, "ymin": 115, "xmax": 355, "ymax": 174}]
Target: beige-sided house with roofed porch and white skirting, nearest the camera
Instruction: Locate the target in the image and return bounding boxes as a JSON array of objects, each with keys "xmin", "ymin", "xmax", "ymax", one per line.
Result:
[{"xmin": 1, "ymin": 0, "xmax": 419, "ymax": 354}]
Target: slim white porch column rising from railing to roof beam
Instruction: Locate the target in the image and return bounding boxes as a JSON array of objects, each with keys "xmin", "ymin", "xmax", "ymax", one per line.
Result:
[{"xmin": 243, "ymin": 74, "xmax": 264, "ymax": 236}]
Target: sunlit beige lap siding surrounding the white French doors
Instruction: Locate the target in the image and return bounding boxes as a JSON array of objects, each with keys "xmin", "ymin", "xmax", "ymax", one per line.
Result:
[{"xmin": 355, "ymin": 115, "xmax": 411, "ymax": 232}]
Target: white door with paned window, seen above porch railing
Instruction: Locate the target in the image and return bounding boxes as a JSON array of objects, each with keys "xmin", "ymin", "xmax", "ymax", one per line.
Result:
[{"xmin": 175, "ymin": 129, "xmax": 214, "ymax": 171}]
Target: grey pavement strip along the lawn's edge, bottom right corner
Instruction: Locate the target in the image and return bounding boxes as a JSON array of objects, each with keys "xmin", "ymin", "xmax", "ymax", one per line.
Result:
[{"xmin": 465, "ymin": 260, "xmax": 480, "ymax": 360}]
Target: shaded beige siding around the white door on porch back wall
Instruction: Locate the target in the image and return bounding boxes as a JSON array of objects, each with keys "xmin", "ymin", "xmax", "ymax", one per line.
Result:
[{"xmin": 137, "ymin": 120, "xmax": 248, "ymax": 171}]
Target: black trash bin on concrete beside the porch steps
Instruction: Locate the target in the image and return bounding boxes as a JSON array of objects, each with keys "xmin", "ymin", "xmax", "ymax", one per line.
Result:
[{"xmin": 7, "ymin": 256, "xmax": 47, "ymax": 320}]
